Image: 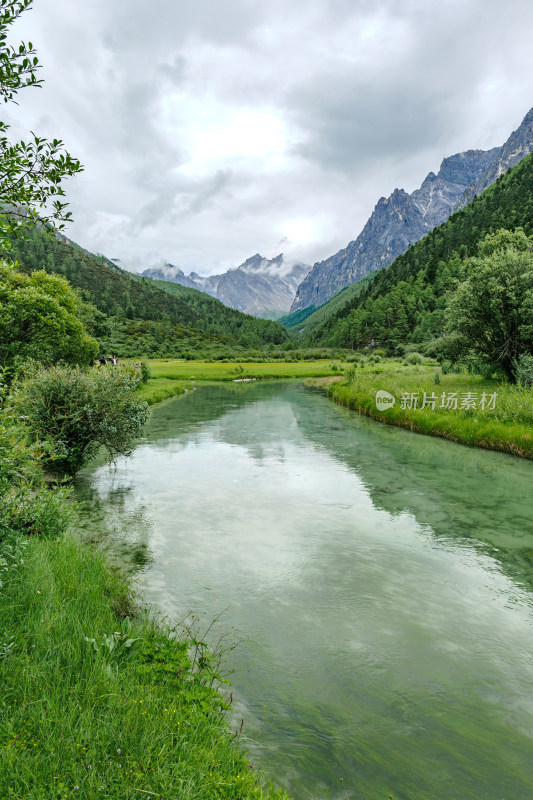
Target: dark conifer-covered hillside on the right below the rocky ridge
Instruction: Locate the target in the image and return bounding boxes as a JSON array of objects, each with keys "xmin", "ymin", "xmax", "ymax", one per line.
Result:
[{"xmin": 307, "ymin": 156, "xmax": 533, "ymax": 353}]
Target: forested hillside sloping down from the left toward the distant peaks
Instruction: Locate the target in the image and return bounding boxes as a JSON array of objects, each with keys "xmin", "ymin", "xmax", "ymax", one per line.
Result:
[{"xmin": 6, "ymin": 228, "xmax": 287, "ymax": 356}]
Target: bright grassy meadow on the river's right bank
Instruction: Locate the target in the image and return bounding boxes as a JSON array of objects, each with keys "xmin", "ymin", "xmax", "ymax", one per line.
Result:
[{"xmin": 322, "ymin": 360, "xmax": 533, "ymax": 458}]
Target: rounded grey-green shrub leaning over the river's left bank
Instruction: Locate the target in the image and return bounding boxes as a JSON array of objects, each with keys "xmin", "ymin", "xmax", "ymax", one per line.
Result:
[{"xmin": 9, "ymin": 366, "xmax": 147, "ymax": 475}]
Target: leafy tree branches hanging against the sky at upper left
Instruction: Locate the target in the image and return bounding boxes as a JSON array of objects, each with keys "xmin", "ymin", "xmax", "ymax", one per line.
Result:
[{"xmin": 0, "ymin": 0, "xmax": 82, "ymax": 242}]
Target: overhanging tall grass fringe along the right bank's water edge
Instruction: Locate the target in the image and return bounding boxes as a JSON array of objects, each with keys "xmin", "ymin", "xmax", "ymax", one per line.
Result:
[{"xmin": 305, "ymin": 378, "xmax": 533, "ymax": 458}]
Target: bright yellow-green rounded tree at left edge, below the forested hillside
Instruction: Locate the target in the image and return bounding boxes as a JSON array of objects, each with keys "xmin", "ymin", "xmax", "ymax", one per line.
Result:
[{"xmin": 0, "ymin": 264, "xmax": 98, "ymax": 366}]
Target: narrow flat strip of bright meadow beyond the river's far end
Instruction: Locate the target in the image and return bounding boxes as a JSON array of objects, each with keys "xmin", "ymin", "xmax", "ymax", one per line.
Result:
[{"xmin": 145, "ymin": 359, "xmax": 346, "ymax": 381}]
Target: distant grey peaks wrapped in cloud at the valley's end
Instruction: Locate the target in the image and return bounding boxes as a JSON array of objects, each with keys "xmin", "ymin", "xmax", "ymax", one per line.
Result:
[{"xmin": 142, "ymin": 253, "xmax": 309, "ymax": 318}]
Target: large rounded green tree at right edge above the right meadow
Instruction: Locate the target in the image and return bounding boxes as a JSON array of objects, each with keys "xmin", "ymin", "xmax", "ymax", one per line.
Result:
[{"xmin": 445, "ymin": 231, "xmax": 533, "ymax": 380}]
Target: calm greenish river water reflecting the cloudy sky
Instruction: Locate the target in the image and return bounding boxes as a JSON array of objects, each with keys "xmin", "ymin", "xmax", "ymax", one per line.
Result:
[{"xmin": 74, "ymin": 383, "xmax": 533, "ymax": 800}]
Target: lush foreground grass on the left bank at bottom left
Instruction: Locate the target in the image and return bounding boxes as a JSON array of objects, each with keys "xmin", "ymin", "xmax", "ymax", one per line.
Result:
[{"xmin": 0, "ymin": 537, "xmax": 285, "ymax": 800}]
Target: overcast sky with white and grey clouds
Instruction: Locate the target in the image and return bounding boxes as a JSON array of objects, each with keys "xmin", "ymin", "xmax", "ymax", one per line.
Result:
[{"xmin": 3, "ymin": 0, "xmax": 533, "ymax": 274}]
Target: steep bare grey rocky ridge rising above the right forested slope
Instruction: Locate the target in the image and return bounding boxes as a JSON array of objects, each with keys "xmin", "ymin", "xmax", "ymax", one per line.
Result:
[{"xmin": 291, "ymin": 109, "xmax": 533, "ymax": 313}]
